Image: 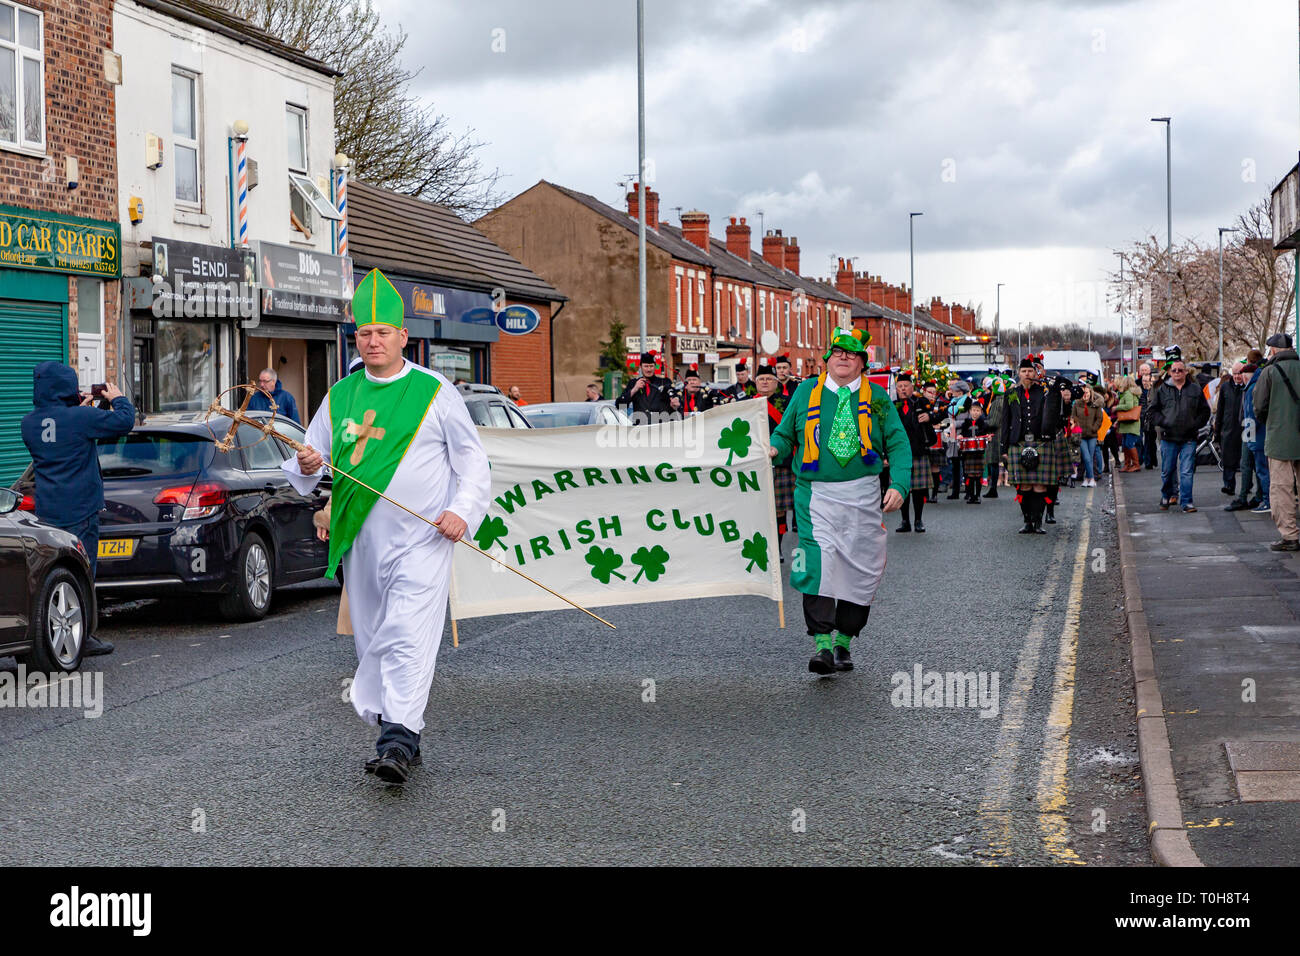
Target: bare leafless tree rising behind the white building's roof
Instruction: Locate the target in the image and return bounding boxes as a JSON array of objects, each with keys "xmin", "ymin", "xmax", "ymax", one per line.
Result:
[{"xmin": 217, "ymin": 0, "xmax": 503, "ymax": 219}]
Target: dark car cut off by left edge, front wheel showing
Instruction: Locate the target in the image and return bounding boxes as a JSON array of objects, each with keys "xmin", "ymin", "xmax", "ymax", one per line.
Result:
[{"xmin": 0, "ymin": 488, "xmax": 98, "ymax": 672}]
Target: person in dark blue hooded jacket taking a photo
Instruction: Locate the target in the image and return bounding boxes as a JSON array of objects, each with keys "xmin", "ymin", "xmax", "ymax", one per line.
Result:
[{"xmin": 22, "ymin": 362, "xmax": 135, "ymax": 657}]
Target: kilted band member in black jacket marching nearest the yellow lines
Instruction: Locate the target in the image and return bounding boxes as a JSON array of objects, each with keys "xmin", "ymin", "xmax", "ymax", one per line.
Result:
[{"xmin": 1002, "ymin": 356, "xmax": 1067, "ymax": 535}]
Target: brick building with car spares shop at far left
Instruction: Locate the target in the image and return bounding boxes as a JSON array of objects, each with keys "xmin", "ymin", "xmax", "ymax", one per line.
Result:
[{"xmin": 0, "ymin": 0, "xmax": 121, "ymax": 484}]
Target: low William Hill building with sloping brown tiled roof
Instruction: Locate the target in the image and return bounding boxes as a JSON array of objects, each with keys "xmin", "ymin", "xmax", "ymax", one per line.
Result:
[{"xmin": 348, "ymin": 182, "xmax": 564, "ymax": 402}]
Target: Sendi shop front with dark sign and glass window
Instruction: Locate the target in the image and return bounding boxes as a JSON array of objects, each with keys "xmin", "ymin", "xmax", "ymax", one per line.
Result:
[{"xmin": 124, "ymin": 235, "xmax": 257, "ymax": 412}]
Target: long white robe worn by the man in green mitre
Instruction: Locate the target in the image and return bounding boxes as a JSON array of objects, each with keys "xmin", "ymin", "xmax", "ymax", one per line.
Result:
[{"xmin": 282, "ymin": 362, "xmax": 491, "ymax": 732}]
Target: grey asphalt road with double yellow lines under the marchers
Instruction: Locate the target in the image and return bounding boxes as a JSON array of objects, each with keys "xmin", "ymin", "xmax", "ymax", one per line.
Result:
[{"xmin": 0, "ymin": 478, "xmax": 1149, "ymax": 865}]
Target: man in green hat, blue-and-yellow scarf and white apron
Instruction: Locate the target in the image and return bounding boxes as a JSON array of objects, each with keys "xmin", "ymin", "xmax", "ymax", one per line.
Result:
[{"xmin": 771, "ymin": 328, "xmax": 911, "ymax": 674}]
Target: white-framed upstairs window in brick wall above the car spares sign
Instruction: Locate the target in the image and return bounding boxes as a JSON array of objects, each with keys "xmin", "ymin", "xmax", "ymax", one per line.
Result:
[{"xmin": 0, "ymin": 0, "xmax": 46, "ymax": 150}]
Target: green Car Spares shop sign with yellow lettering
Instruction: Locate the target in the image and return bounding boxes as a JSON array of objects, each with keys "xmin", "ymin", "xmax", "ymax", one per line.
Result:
[{"xmin": 0, "ymin": 206, "xmax": 122, "ymax": 278}]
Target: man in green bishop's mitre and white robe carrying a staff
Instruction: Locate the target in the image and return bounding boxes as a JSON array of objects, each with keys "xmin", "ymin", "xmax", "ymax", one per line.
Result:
[{"xmin": 283, "ymin": 269, "xmax": 491, "ymax": 783}]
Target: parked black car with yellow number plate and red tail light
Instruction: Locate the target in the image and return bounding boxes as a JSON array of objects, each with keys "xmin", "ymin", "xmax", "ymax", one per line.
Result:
[{"xmin": 14, "ymin": 412, "xmax": 330, "ymax": 620}]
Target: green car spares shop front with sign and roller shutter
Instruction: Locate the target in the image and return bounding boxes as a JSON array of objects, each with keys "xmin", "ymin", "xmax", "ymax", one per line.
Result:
[{"xmin": 0, "ymin": 206, "xmax": 122, "ymax": 485}]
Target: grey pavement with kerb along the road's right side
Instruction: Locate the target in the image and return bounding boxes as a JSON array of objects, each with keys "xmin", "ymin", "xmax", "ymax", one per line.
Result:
[{"xmin": 1117, "ymin": 467, "xmax": 1300, "ymax": 866}]
